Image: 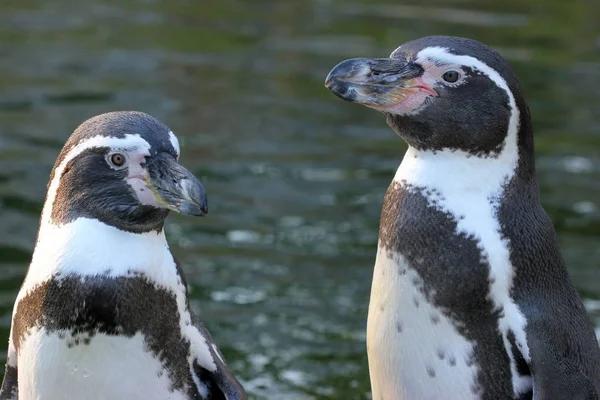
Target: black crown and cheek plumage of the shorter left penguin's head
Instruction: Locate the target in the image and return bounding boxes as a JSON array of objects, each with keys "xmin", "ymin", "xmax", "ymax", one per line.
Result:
[{"xmin": 49, "ymin": 112, "xmax": 185, "ymax": 233}]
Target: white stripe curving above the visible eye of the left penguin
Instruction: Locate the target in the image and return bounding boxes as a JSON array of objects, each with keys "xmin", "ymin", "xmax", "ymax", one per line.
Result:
[{"xmin": 40, "ymin": 134, "xmax": 150, "ymax": 229}]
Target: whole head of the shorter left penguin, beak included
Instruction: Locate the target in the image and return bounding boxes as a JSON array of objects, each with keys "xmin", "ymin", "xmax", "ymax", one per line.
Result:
[{"xmin": 42, "ymin": 112, "xmax": 208, "ymax": 233}]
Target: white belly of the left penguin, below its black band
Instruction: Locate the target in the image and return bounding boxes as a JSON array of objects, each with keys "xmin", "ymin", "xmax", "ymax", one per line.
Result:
[{"xmin": 18, "ymin": 330, "xmax": 187, "ymax": 400}]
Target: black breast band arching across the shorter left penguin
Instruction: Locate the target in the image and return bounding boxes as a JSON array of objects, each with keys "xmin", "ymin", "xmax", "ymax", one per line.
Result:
[{"xmin": 12, "ymin": 275, "xmax": 209, "ymax": 399}]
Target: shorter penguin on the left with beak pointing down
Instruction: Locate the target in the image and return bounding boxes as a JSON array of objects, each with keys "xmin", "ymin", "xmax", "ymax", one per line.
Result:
[{"xmin": 0, "ymin": 112, "xmax": 247, "ymax": 400}]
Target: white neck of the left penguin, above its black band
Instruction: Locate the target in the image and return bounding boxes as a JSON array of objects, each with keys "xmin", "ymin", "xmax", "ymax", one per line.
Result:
[{"xmin": 26, "ymin": 218, "xmax": 173, "ymax": 285}]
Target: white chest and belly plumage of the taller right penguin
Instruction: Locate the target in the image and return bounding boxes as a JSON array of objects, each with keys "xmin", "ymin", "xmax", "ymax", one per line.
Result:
[{"xmin": 367, "ymin": 148, "xmax": 531, "ymax": 400}]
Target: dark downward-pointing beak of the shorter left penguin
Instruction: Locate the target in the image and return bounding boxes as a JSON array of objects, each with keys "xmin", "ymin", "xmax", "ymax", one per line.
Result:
[{"xmin": 145, "ymin": 153, "xmax": 208, "ymax": 216}]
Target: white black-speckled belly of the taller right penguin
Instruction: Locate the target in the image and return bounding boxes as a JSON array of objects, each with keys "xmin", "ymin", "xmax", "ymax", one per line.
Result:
[{"xmin": 367, "ymin": 249, "xmax": 479, "ymax": 400}]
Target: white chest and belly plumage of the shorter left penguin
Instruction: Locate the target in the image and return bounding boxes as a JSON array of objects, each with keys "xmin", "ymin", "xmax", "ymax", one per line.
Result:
[{"xmin": 9, "ymin": 218, "xmax": 216, "ymax": 400}]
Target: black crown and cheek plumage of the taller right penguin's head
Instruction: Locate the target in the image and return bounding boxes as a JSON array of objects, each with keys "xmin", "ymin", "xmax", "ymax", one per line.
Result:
[{"xmin": 387, "ymin": 36, "xmax": 532, "ymax": 156}]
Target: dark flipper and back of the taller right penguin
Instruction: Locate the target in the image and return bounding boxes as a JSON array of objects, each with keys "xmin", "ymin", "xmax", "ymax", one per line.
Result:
[{"xmin": 500, "ymin": 203, "xmax": 600, "ymax": 400}]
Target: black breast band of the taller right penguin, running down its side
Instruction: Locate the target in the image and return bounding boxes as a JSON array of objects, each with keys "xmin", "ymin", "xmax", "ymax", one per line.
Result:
[{"xmin": 376, "ymin": 182, "xmax": 513, "ymax": 398}]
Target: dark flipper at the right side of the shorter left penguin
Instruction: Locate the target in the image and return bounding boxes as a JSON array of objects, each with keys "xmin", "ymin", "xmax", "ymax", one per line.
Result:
[{"xmin": 192, "ymin": 313, "xmax": 248, "ymax": 400}]
